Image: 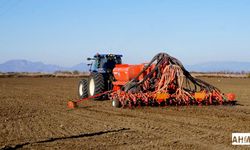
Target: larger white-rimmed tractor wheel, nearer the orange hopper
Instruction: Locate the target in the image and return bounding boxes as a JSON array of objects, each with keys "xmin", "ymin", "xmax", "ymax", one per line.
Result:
[{"xmin": 88, "ymin": 73, "xmax": 105, "ymax": 100}]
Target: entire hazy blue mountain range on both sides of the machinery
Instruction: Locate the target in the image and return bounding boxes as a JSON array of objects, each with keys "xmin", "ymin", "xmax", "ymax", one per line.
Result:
[{"xmin": 0, "ymin": 60, "xmax": 250, "ymax": 73}]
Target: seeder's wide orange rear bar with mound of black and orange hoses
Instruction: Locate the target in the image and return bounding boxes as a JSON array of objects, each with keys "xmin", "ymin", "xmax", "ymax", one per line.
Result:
[{"xmin": 109, "ymin": 53, "xmax": 236, "ymax": 107}]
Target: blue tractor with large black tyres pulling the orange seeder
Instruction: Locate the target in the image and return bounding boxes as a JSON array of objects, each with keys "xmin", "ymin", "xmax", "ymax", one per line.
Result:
[{"xmin": 78, "ymin": 53, "xmax": 122, "ymax": 100}]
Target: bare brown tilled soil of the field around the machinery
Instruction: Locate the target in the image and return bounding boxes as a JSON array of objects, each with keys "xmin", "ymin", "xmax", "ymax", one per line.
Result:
[{"xmin": 0, "ymin": 78, "xmax": 250, "ymax": 149}]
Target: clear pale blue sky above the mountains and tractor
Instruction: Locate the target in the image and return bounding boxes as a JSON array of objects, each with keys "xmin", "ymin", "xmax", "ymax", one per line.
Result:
[{"xmin": 0, "ymin": 0, "xmax": 250, "ymax": 66}]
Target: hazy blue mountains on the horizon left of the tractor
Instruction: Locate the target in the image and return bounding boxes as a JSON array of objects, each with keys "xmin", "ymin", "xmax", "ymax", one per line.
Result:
[{"xmin": 0, "ymin": 60, "xmax": 88, "ymax": 73}]
